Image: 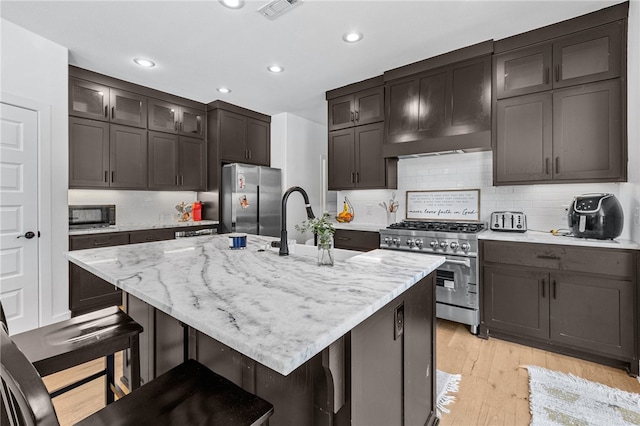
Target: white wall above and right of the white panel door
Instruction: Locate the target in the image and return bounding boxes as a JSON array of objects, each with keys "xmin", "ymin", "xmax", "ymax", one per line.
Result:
[{"xmin": 0, "ymin": 19, "xmax": 69, "ymax": 325}]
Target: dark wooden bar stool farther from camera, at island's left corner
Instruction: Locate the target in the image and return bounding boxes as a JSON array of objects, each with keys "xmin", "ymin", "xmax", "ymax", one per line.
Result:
[{"xmin": 0, "ymin": 304, "xmax": 142, "ymax": 404}]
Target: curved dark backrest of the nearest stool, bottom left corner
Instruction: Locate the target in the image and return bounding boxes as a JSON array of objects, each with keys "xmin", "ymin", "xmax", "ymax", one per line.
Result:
[{"xmin": 0, "ymin": 326, "xmax": 59, "ymax": 426}]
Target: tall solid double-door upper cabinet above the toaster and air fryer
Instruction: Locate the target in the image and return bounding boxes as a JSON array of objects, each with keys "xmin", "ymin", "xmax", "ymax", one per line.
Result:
[{"xmin": 494, "ymin": 79, "xmax": 626, "ymax": 185}]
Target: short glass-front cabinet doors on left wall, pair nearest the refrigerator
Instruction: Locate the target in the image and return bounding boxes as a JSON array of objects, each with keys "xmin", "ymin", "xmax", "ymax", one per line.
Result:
[{"xmin": 149, "ymin": 99, "xmax": 205, "ymax": 138}]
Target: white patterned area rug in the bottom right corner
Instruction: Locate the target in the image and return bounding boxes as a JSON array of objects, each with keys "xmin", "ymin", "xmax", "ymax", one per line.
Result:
[{"xmin": 525, "ymin": 365, "xmax": 640, "ymax": 426}]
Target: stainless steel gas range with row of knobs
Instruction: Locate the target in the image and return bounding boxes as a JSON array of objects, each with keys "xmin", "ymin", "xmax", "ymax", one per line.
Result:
[{"xmin": 380, "ymin": 221, "xmax": 485, "ymax": 334}]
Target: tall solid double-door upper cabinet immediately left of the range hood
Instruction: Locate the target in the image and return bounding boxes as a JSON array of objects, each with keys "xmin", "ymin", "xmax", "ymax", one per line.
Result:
[{"xmin": 328, "ymin": 123, "xmax": 397, "ymax": 191}]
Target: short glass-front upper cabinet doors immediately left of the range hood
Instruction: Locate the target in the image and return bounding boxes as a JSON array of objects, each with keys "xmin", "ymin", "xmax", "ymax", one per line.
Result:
[{"xmin": 329, "ymin": 86, "xmax": 384, "ymax": 131}]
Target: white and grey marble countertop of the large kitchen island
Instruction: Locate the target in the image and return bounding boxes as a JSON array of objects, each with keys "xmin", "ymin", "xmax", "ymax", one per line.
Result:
[{"xmin": 65, "ymin": 235, "xmax": 444, "ymax": 375}]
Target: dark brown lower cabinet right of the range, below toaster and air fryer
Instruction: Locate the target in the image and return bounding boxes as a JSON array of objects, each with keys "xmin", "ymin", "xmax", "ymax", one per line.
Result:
[{"xmin": 480, "ymin": 241, "xmax": 639, "ymax": 374}]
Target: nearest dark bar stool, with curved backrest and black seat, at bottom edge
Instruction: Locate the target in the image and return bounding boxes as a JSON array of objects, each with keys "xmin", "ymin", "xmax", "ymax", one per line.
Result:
[{"xmin": 0, "ymin": 327, "xmax": 273, "ymax": 426}]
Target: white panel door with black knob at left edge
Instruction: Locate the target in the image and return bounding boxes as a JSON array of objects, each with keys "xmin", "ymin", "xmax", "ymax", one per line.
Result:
[{"xmin": 0, "ymin": 103, "xmax": 39, "ymax": 334}]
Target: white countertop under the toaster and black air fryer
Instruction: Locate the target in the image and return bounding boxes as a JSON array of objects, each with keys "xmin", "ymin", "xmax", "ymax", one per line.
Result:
[{"xmin": 478, "ymin": 230, "xmax": 640, "ymax": 250}]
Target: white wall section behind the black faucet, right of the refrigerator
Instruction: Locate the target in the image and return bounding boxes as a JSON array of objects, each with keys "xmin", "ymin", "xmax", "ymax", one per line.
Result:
[{"xmin": 271, "ymin": 113, "xmax": 327, "ymax": 243}]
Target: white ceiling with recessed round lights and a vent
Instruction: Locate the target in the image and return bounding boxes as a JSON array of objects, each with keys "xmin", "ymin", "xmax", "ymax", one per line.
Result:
[{"xmin": 0, "ymin": 0, "xmax": 620, "ymax": 124}]
